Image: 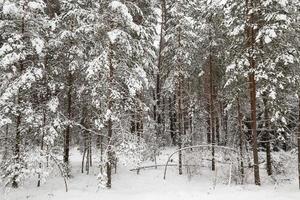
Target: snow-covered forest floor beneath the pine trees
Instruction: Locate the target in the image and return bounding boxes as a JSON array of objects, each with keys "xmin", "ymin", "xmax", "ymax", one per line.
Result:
[{"xmin": 0, "ymin": 150, "xmax": 300, "ymax": 200}]
